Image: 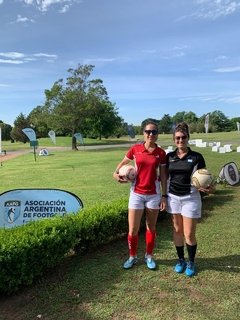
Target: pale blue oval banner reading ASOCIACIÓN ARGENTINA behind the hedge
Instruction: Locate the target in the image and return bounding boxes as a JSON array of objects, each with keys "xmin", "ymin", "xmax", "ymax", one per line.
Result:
[{"xmin": 0, "ymin": 189, "xmax": 83, "ymax": 228}]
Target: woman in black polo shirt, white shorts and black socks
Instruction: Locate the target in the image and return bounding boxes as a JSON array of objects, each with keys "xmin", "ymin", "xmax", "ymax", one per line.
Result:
[{"xmin": 167, "ymin": 122, "xmax": 214, "ymax": 277}]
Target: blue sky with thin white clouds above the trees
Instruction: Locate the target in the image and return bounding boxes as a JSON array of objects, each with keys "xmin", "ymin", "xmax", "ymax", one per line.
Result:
[{"xmin": 0, "ymin": 0, "xmax": 240, "ymax": 125}]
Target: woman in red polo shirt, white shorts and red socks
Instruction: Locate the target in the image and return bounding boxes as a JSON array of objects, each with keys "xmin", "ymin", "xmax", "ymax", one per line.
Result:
[{"xmin": 113, "ymin": 121, "xmax": 167, "ymax": 270}]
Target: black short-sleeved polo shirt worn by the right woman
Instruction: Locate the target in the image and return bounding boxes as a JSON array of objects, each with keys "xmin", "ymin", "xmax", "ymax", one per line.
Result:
[{"xmin": 167, "ymin": 148, "xmax": 206, "ymax": 196}]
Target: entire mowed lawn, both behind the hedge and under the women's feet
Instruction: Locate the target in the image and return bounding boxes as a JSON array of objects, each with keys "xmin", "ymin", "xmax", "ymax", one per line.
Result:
[{"xmin": 0, "ymin": 135, "xmax": 240, "ymax": 320}]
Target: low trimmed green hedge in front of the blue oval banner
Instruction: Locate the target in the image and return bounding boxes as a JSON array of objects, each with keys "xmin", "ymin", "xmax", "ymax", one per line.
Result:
[{"xmin": 0, "ymin": 199, "xmax": 128, "ymax": 293}]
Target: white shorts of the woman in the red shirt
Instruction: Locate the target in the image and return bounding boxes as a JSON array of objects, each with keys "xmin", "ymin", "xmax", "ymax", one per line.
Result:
[{"xmin": 128, "ymin": 191, "xmax": 161, "ymax": 209}]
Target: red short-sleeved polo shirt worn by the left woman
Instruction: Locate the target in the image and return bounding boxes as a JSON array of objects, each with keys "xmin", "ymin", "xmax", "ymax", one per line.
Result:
[{"xmin": 126, "ymin": 143, "xmax": 166, "ymax": 195}]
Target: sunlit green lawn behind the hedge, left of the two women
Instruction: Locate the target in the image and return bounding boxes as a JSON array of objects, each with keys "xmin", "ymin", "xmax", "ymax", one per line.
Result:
[{"xmin": 0, "ymin": 148, "xmax": 129, "ymax": 206}]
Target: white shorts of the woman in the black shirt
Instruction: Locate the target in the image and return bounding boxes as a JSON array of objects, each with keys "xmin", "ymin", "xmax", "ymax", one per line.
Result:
[{"xmin": 167, "ymin": 191, "xmax": 202, "ymax": 218}]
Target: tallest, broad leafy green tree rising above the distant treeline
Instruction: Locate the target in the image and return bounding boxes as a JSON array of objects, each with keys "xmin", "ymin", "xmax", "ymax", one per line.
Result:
[{"xmin": 45, "ymin": 65, "xmax": 119, "ymax": 149}]
